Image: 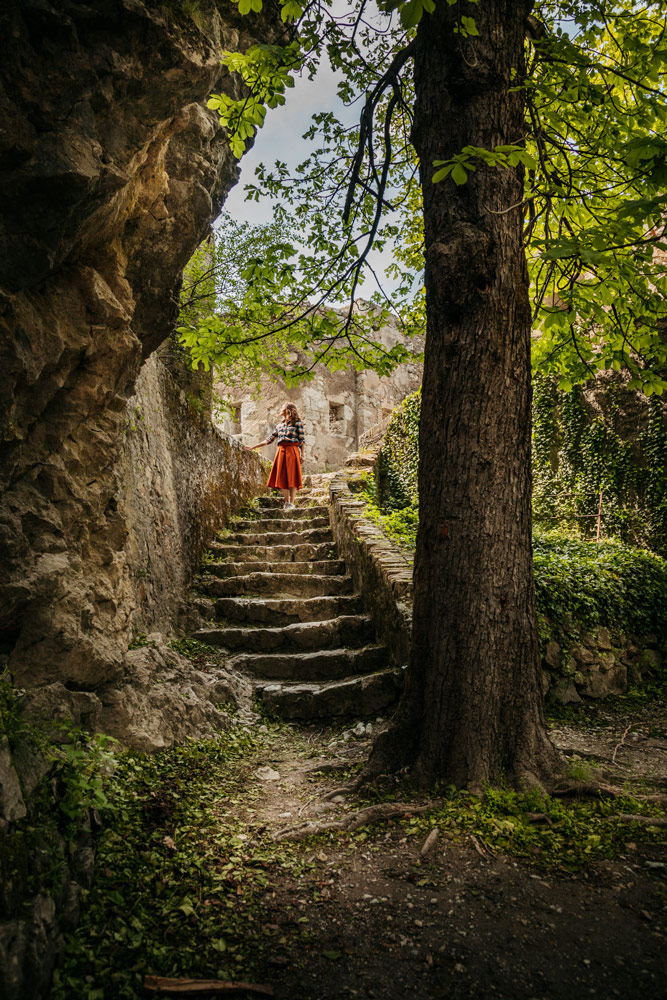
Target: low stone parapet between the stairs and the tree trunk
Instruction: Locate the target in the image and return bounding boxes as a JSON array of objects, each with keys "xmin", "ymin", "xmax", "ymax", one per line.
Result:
[{"xmin": 329, "ymin": 456, "xmax": 412, "ymax": 666}]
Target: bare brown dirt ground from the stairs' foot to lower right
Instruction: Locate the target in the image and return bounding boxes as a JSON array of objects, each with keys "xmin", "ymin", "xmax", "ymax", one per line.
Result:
[{"xmin": 215, "ymin": 712, "xmax": 667, "ymax": 1000}]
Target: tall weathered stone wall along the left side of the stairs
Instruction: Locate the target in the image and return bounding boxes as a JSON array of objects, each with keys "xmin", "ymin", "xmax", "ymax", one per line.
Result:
[{"xmin": 117, "ymin": 348, "xmax": 266, "ymax": 633}]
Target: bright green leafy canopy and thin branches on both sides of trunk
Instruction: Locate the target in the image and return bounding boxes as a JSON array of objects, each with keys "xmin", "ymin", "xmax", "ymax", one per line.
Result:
[{"xmin": 177, "ymin": 0, "xmax": 667, "ymax": 394}]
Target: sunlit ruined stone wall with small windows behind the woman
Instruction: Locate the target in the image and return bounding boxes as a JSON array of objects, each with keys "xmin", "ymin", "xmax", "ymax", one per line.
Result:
[{"xmin": 214, "ymin": 312, "xmax": 422, "ymax": 472}]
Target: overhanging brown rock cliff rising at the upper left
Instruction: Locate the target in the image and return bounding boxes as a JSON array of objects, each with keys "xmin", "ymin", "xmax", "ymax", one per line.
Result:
[{"xmin": 0, "ymin": 0, "xmax": 277, "ymax": 689}]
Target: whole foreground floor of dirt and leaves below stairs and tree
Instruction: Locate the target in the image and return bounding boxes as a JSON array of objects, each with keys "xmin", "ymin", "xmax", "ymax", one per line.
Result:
[{"xmin": 53, "ymin": 706, "xmax": 667, "ymax": 1000}]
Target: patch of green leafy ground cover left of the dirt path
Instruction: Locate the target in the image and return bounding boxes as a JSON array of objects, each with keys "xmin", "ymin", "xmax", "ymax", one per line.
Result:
[{"xmin": 51, "ymin": 729, "xmax": 308, "ymax": 1000}]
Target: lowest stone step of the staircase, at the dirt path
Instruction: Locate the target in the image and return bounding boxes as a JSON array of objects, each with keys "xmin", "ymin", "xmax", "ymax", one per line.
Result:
[{"xmin": 255, "ymin": 669, "xmax": 403, "ymax": 719}]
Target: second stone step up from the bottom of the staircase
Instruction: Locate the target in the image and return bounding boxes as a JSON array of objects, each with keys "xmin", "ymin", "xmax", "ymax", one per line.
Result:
[{"xmin": 230, "ymin": 646, "xmax": 389, "ymax": 683}]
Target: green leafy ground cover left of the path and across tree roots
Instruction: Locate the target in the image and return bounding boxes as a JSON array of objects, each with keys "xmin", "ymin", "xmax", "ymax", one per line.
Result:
[{"xmin": 51, "ymin": 723, "xmax": 667, "ymax": 1000}]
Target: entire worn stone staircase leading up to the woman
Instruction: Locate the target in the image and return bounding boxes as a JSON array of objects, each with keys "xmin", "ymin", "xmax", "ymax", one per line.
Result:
[{"xmin": 195, "ymin": 477, "xmax": 403, "ymax": 720}]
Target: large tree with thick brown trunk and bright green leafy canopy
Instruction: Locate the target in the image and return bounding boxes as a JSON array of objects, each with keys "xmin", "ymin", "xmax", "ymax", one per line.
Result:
[{"xmin": 197, "ymin": 0, "xmax": 667, "ymax": 787}]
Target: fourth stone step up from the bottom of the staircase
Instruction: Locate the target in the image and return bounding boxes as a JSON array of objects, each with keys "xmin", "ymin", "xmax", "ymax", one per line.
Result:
[{"xmin": 215, "ymin": 594, "xmax": 363, "ymax": 627}]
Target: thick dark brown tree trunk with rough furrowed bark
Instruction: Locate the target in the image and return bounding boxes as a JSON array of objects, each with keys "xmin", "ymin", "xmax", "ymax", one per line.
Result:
[{"xmin": 369, "ymin": 0, "xmax": 557, "ymax": 788}]
